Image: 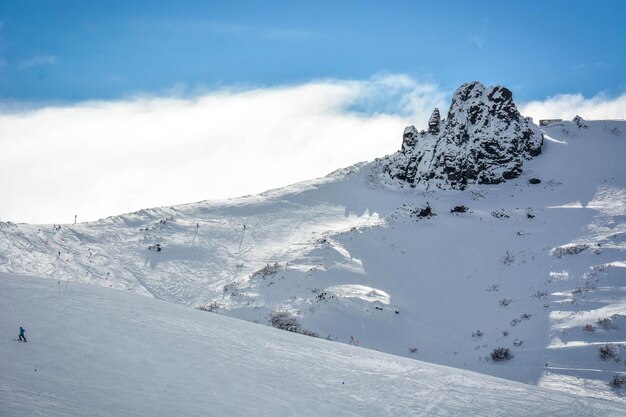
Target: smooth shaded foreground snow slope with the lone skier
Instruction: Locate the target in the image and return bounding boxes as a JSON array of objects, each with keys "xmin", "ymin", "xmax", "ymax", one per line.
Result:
[{"xmin": 0, "ymin": 274, "xmax": 626, "ymax": 417}]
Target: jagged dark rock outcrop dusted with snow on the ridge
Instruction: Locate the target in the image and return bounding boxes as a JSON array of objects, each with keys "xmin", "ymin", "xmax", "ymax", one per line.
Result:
[{"xmin": 383, "ymin": 82, "xmax": 543, "ymax": 189}]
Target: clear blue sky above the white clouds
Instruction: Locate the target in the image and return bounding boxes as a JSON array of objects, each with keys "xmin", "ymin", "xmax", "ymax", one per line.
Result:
[{"xmin": 0, "ymin": 0, "xmax": 626, "ymax": 102}]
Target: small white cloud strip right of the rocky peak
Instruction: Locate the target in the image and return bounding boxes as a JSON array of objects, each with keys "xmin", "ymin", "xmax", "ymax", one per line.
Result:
[{"xmin": 519, "ymin": 94, "xmax": 626, "ymax": 123}]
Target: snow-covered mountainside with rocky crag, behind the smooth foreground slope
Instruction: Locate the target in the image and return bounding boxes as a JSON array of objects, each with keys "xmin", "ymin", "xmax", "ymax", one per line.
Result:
[{"xmin": 0, "ymin": 83, "xmax": 626, "ymax": 403}]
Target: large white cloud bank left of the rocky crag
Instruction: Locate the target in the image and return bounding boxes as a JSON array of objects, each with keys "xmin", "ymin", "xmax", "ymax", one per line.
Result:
[{"xmin": 0, "ymin": 75, "xmax": 444, "ymax": 223}]
